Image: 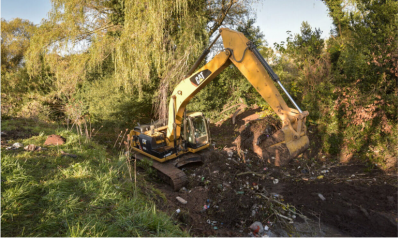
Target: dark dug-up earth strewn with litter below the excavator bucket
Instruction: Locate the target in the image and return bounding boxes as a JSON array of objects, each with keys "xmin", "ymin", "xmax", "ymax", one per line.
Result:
[{"xmin": 150, "ymin": 109, "xmax": 398, "ymax": 237}]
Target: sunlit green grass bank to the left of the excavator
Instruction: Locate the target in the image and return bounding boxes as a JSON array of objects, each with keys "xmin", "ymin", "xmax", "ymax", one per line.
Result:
[{"xmin": 1, "ymin": 121, "xmax": 189, "ymax": 237}]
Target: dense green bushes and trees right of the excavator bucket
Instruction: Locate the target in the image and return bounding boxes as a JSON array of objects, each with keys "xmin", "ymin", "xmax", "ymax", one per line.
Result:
[{"xmin": 274, "ymin": 0, "xmax": 398, "ymax": 169}]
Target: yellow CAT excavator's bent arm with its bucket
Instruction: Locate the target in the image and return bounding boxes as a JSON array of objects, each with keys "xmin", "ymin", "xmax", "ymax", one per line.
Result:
[{"xmin": 167, "ymin": 28, "xmax": 309, "ymax": 161}]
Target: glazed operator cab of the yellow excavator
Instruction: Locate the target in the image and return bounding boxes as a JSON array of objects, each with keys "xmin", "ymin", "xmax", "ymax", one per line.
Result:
[{"xmin": 184, "ymin": 112, "xmax": 210, "ymax": 149}]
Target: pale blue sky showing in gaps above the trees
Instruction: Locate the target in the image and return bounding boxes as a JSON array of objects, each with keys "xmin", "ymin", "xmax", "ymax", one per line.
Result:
[{"xmin": 1, "ymin": 0, "xmax": 332, "ymax": 47}]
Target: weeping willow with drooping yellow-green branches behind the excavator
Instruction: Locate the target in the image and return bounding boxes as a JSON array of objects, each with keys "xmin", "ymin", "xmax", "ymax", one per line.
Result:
[{"xmin": 27, "ymin": 0, "xmax": 258, "ymax": 121}]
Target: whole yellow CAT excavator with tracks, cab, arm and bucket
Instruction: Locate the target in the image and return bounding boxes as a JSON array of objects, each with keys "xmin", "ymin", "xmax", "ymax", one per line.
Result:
[{"xmin": 128, "ymin": 28, "xmax": 309, "ymax": 190}]
